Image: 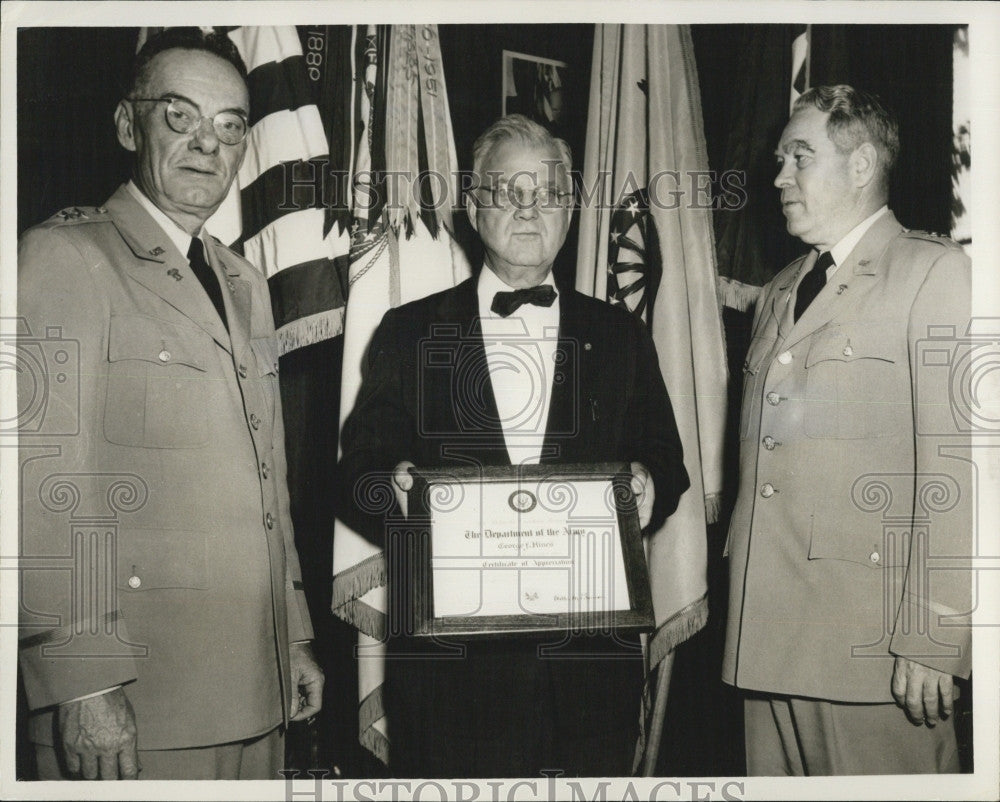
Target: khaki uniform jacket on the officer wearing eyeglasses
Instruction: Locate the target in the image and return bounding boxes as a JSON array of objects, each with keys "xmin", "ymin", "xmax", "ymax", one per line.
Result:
[{"xmin": 18, "ymin": 187, "xmax": 312, "ymax": 749}]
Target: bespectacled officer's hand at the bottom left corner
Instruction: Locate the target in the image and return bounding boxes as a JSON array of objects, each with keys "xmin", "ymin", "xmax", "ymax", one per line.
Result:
[{"xmin": 59, "ymin": 688, "xmax": 139, "ymax": 780}]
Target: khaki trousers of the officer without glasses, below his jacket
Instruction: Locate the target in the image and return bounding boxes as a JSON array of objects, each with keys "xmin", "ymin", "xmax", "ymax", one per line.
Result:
[{"xmin": 745, "ymin": 694, "xmax": 959, "ymax": 777}]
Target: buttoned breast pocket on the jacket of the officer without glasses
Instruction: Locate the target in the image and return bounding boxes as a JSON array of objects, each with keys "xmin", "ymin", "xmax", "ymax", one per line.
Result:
[{"xmin": 805, "ymin": 324, "xmax": 912, "ymax": 440}]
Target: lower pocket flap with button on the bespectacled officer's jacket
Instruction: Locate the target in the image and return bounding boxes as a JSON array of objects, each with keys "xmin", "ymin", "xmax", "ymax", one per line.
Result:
[{"xmin": 117, "ymin": 529, "xmax": 208, "ymax": 593}]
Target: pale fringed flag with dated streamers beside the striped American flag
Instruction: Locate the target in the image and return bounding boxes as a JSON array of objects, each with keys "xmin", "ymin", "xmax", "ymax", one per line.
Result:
[{"xmin": 333, "ymin": 25, "xmax": 470, "ymax": 763}]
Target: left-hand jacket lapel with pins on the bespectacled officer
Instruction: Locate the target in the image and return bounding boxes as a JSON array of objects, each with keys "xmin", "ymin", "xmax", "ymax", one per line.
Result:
[{"xmin": 106, "ymin": 187, "xmax": 232, "ymax": 352}]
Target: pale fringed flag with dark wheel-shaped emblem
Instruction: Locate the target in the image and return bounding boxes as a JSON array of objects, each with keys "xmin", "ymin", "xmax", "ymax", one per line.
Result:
[{"xmin": 576, "ymin": 25, "xmax": 727, "ymax": 764}]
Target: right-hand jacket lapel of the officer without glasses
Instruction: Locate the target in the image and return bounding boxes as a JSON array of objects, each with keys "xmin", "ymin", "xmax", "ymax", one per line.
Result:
[{"xmin": 785, "ymin": 212, "xmax": 903, "ymax": 348}]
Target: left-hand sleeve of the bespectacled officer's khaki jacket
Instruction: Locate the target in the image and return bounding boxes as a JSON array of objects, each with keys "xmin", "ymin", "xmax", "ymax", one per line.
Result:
[{"xmin": 17, "ymin": 228, "xmax": 136, "ymax": 709}]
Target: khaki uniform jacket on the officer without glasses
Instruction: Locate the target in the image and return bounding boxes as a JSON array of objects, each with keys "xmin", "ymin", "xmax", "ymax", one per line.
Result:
[{"xmin": 723, "ymin": 213, "xmax": 974, "ymax": 702}]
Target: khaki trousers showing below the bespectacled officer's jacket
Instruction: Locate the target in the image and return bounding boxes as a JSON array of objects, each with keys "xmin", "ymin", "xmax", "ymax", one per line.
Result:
[{"xmin": 35, "ymin": 727, "xmax": 285, "ymax": 780}]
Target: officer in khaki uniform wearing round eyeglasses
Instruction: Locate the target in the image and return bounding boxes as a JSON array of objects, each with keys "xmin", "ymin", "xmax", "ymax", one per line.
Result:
[{"xmin": 18, "ymin": 29, "xmax": 323, "ymax": 780}]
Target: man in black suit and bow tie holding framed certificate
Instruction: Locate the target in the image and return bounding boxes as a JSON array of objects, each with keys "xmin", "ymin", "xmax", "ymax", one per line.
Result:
[{"xmin": 338, "ymin": 115, "xmax": 688, "ymax": 777}]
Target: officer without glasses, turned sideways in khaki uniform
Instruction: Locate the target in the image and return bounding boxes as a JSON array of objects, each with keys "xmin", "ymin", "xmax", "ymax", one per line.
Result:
[{"xmin": 723, "ymin": 86, "xmax": 972, "ymax": 775}]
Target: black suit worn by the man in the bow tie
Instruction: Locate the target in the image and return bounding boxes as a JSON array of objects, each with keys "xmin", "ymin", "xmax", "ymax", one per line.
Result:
[{"xmin": 339, "ymin": 278, "xmax": 688, "ymax": 776}]
